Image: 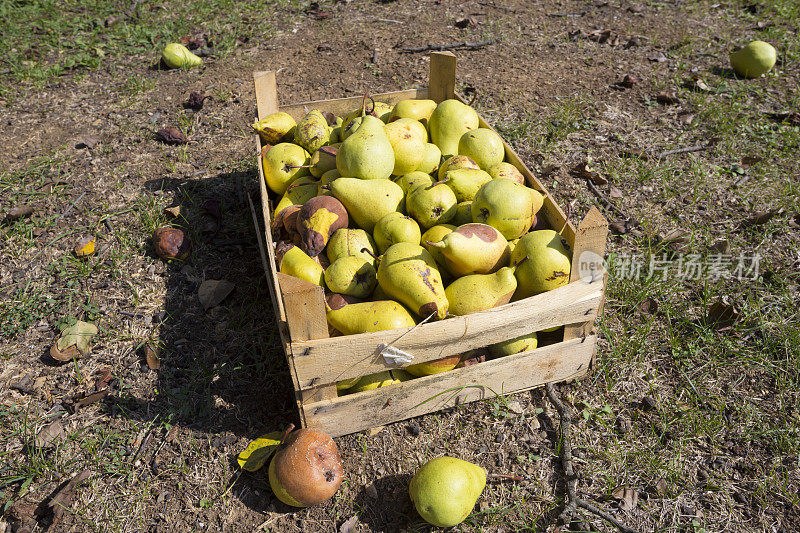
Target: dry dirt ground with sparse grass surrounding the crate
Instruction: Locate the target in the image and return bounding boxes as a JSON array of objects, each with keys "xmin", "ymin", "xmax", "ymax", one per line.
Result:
[{"xmin": 0, "ymin": 0, "xmax": 800, "ymax": 533}]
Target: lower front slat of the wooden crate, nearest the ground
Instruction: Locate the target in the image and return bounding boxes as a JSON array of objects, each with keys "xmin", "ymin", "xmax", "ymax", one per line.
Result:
[{"xmin": 304, "ymin": 337, "xmax": 597, "ymax": 437}]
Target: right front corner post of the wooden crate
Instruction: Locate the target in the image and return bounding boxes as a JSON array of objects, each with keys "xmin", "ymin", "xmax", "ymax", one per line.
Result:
[{"xmin": 564, "ymin": 206, "xmax": 608, "ymax": 340}]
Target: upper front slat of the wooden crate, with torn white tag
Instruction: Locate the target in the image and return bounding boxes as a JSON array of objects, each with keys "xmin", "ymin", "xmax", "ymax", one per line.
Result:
[{"xmin": 292, "ymin": 280, "xmax": 602, "ymax": 388}]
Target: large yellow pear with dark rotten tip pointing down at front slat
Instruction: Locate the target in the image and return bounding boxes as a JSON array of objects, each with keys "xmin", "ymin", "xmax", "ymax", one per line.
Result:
[{"xmin": 378, "ymin": 242, "xmax": 448, "ymax": 319}]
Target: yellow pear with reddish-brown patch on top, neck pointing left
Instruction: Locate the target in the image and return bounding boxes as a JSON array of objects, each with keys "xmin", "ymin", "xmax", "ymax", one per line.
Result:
[{"xmin": 426, "ymin": 224, "xmax": 508, "ymax": 277}]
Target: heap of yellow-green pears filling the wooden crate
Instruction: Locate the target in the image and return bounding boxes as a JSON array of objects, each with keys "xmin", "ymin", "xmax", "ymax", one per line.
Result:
[{"xmin": 253, "ymin": 97, "xmax": 571, "ymax": 395}]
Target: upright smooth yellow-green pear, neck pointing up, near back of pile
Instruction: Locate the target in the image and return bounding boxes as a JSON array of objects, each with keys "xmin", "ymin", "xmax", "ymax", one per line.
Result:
[{"xmin": 336, "ymin": 115, "xmax": 394, "ymax": 180}]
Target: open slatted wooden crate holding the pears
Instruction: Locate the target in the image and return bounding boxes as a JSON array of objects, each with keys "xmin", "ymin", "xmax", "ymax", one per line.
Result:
[{"xmin": 254, "ymin": 52, "xmax": 608, "ymax": 436}]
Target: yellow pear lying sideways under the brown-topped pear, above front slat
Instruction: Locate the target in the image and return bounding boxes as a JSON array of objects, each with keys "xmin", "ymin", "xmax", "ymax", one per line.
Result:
[{"xmin": 445, "ymin": 267, "xmax": 517, "ymax": 316}]
